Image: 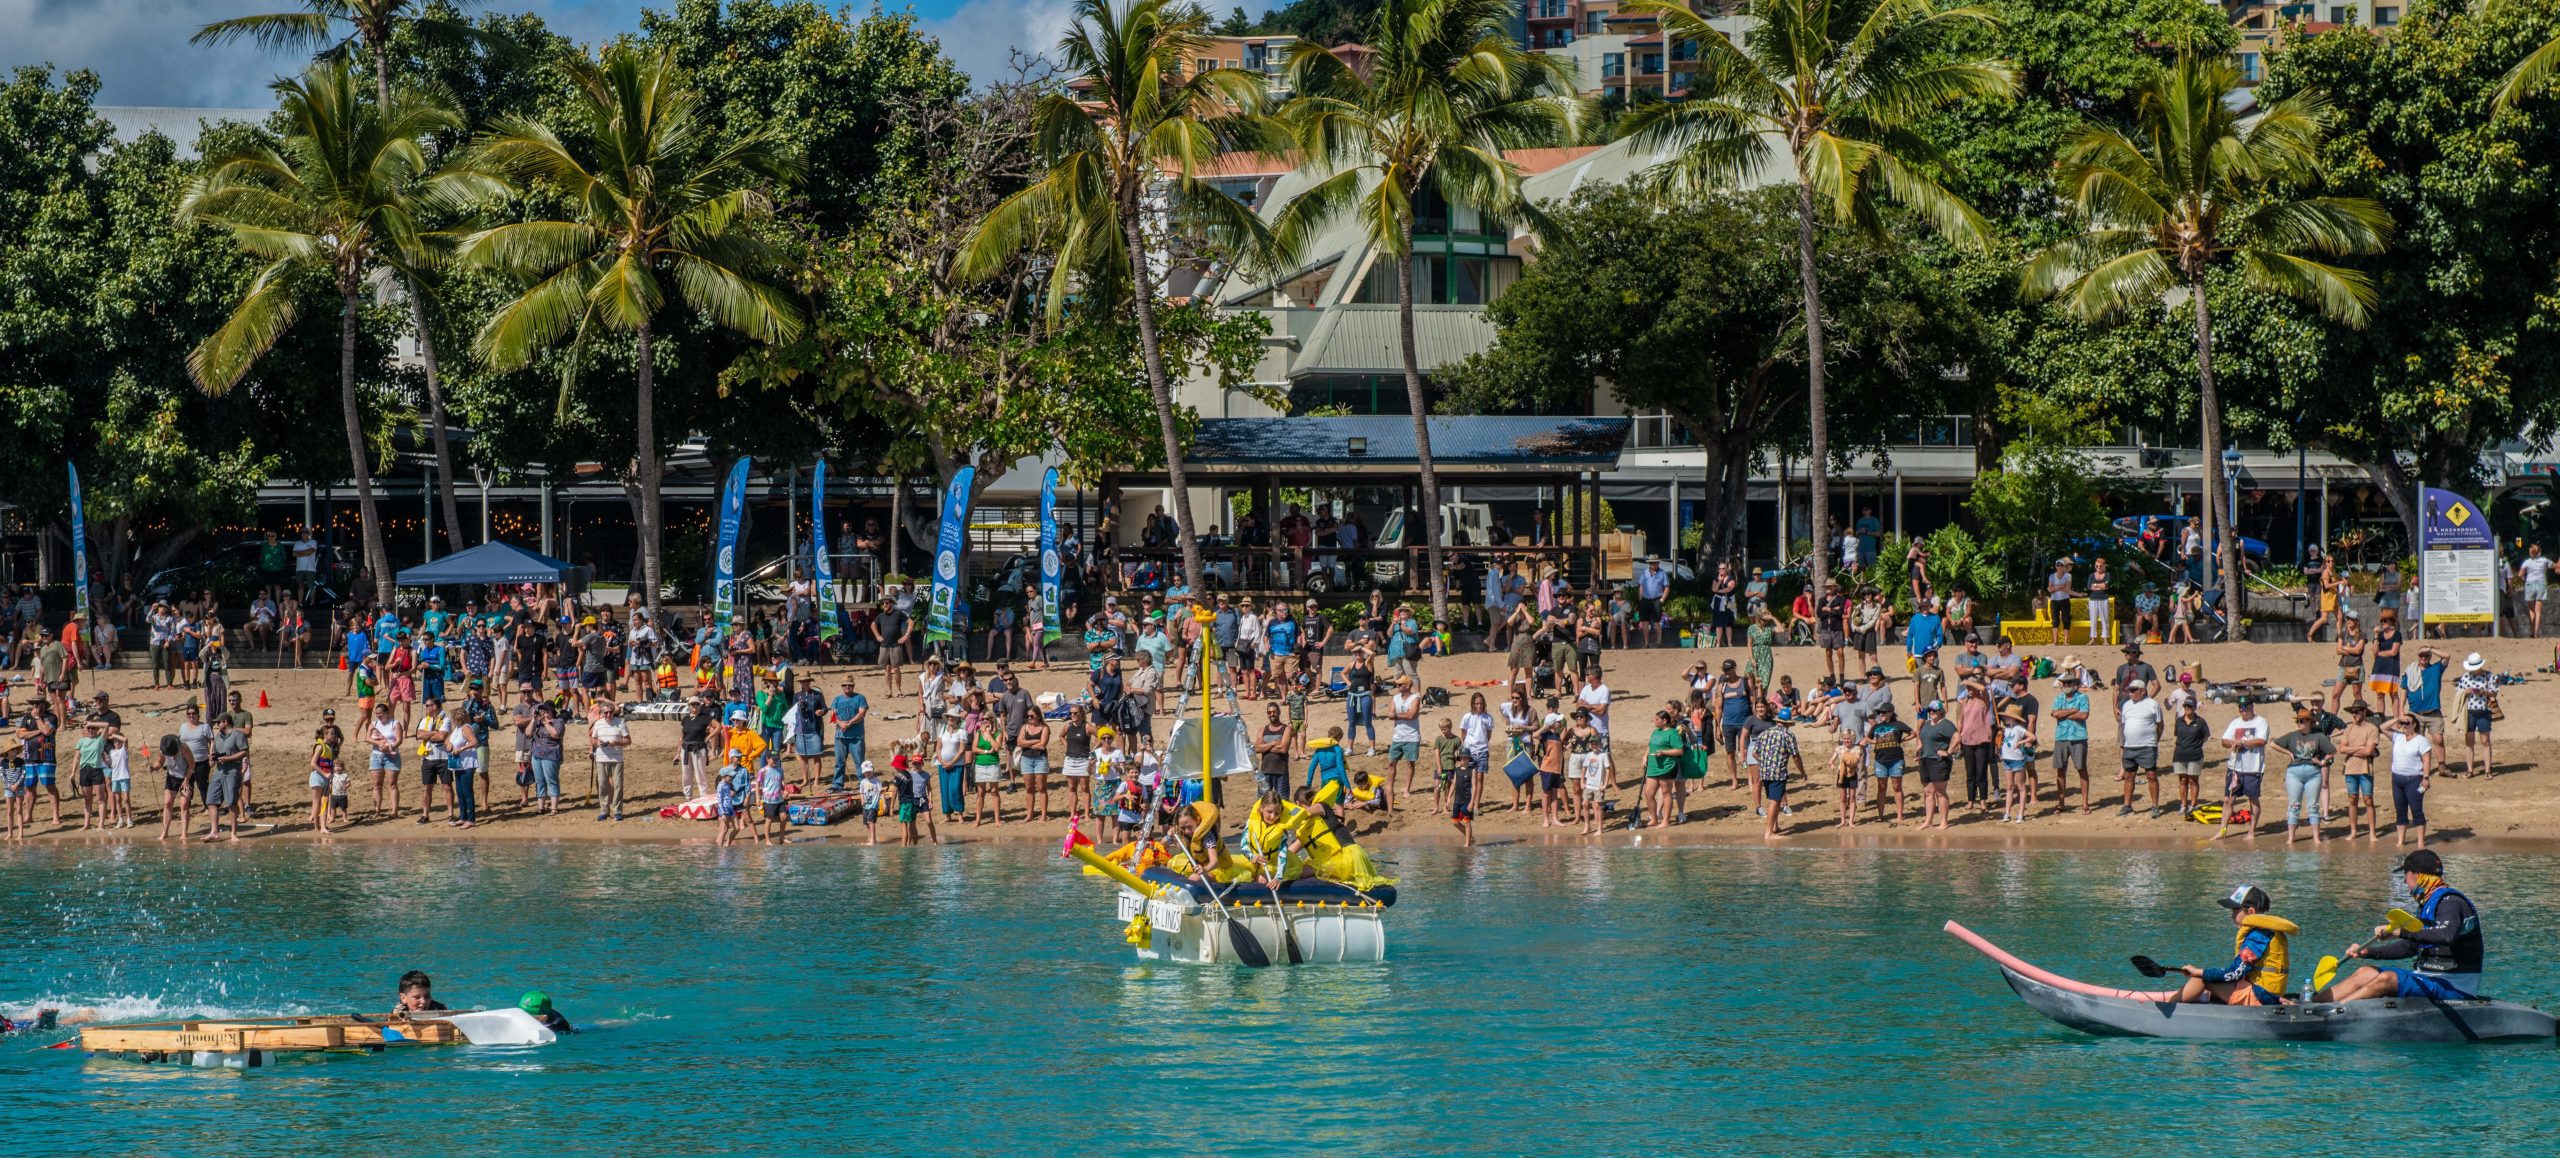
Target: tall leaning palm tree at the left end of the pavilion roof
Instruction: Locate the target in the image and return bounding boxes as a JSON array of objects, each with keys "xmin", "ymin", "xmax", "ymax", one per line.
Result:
[{"xmin": 957, "ymin": 0, "xmax": 1267, "ymax": 596}]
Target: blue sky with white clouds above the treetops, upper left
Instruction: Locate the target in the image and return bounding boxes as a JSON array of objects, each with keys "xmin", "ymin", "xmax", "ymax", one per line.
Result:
[{"xmin": 0, "ymin": 0, "xmax": 1267, "ymax": 108}]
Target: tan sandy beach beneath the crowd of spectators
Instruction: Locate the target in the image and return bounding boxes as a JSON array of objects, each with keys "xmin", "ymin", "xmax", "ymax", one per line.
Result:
[{"xmin": 13, "ymin": 627, "xmax": 2560, "ymax": 851}]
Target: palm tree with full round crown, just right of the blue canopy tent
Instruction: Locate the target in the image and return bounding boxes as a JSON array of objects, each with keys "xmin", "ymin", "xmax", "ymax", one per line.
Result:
[{"xmin": 456, "ymin": 46, "xmax": 801, "ymax": 627}]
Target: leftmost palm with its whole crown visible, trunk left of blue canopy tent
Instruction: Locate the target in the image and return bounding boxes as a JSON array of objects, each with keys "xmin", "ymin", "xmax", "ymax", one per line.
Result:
[{"xmin": 177, "ymin": 59, "xmax": 461, "ymax": 605}]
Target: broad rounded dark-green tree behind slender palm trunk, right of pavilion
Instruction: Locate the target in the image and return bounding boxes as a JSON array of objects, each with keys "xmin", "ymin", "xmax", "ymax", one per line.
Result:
[{"xmin": 1441, "ymin": 184, "xmax": 1971, "ymax": 559}]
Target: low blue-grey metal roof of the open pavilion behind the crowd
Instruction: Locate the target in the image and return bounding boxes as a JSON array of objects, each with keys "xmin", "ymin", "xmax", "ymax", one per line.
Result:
[{"xmin": 1183, "ymin": 415, "xmax": 1631, "ymax": 469}]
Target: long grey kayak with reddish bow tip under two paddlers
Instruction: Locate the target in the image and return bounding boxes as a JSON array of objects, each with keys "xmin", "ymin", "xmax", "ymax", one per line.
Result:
[{"xmin": 1946, "ymin": 920, "xmax": 2555, "ymax": 1043}]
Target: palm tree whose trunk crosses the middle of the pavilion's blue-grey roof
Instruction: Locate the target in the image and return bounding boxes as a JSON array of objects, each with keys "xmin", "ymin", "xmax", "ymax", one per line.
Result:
[{"xmin": 1272, "ymin": 0, "xmax": 1582, "ymax": 623}]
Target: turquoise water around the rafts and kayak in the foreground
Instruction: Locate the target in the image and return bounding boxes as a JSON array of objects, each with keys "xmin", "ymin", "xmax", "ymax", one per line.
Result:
[{"xmin": 0, "ymin": 843, "xmax": 2560, "ymax": 1155}]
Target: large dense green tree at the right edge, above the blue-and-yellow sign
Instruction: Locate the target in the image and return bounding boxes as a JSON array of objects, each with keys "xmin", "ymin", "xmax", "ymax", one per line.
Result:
[{"xmin": 2263, "ymin": 3, "xmax": 2560, "ymax": 545}]
